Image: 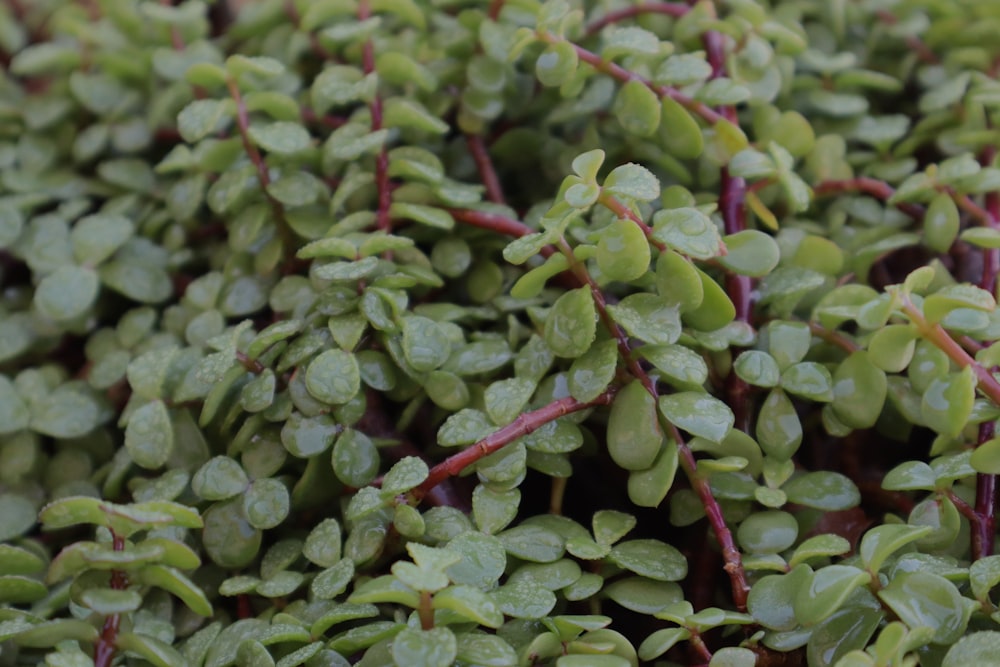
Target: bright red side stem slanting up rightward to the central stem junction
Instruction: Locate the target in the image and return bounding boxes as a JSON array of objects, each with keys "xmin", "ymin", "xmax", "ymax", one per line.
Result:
[{"xmin": 411, "ymin": 388, "xmax": 615, "ymax": 500}]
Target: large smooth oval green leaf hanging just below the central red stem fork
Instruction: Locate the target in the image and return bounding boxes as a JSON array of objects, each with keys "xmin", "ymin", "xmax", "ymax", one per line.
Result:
[{"xmin": 607, "ymin": 380, "xmax": 666, "ymax": 470}]
